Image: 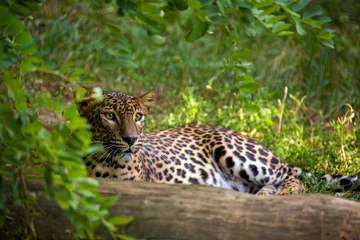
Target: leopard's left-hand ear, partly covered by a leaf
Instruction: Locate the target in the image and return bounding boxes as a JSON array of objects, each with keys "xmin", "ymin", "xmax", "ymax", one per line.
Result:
[{"xmin": 74, "ymin": 86, "xmax": 103, "ymax": 116}]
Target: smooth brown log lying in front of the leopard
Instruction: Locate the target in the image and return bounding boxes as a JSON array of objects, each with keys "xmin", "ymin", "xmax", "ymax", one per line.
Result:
[{"xmin": 0, "ymin": 179, "xmax": 360, "ymax": 240}]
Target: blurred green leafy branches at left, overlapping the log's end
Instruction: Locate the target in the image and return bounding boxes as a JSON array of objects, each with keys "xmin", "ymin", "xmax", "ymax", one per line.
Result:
[{"xmin": 0, "ymin": 1, "xmax": 131, "ymax": 239}]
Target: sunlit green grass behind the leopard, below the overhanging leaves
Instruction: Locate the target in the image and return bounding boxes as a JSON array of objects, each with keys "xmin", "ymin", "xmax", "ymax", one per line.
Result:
[{"xmin": 32, "ymin": 0, "xmax": 360, "ymax": 197}]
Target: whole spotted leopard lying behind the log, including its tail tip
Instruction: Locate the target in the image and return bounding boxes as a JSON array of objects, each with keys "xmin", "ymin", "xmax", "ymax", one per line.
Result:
[{"xmin": 77, "ymin": 91, "xmax": 357, "ymax": 195}]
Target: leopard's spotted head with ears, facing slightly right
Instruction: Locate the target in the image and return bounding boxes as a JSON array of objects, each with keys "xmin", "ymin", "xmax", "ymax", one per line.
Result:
[{"xmin": 78, "ymin": 91, "xmax": 156, "ymax": 161}]
